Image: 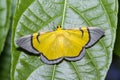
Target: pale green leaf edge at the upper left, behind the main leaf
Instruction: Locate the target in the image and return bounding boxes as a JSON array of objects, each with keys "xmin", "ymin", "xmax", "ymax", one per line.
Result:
[{"xmin": 0, "ymin": 0, "xmax": 11, "ymax": 53}]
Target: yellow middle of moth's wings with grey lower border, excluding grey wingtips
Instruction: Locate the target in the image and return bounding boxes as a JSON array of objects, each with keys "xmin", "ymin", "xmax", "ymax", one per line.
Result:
[{"xmin": 32, "ymin": 28, "xmax": 89, "ymax": 64}]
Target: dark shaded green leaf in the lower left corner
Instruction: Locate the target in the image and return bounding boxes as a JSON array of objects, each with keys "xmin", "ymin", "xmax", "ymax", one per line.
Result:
[{"xmin": 0, "ymin": 31, "xmax": 11, "ymax": 80}]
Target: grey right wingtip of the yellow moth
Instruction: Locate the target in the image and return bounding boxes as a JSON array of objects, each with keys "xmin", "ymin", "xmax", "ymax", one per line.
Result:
[{"xmin": 85, "ymin": 27, "xmax": 105, "ymax": 48}]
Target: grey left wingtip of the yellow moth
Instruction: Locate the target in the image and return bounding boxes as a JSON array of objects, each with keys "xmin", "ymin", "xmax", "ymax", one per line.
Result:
[{"xmin": 16, "ymin": 35, "xmax": 39, "ymax": 54}]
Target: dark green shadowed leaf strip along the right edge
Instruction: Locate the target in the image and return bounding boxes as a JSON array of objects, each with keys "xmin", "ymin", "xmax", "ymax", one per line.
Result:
[{"xmin": 114, "ymin": 1, "xmax": 120, "ymax": 57}]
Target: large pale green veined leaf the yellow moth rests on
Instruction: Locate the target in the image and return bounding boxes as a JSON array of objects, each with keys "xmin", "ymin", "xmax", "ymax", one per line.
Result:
[{"xmin": 11, "ymin": 0, "xmax": 118, "ymax": 80}]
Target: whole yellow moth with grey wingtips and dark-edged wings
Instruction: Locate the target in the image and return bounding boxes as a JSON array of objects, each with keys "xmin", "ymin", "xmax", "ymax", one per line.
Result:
[{"xmin": 17, "ymin": 26, "xmax": 104, "ymax": 64}]
